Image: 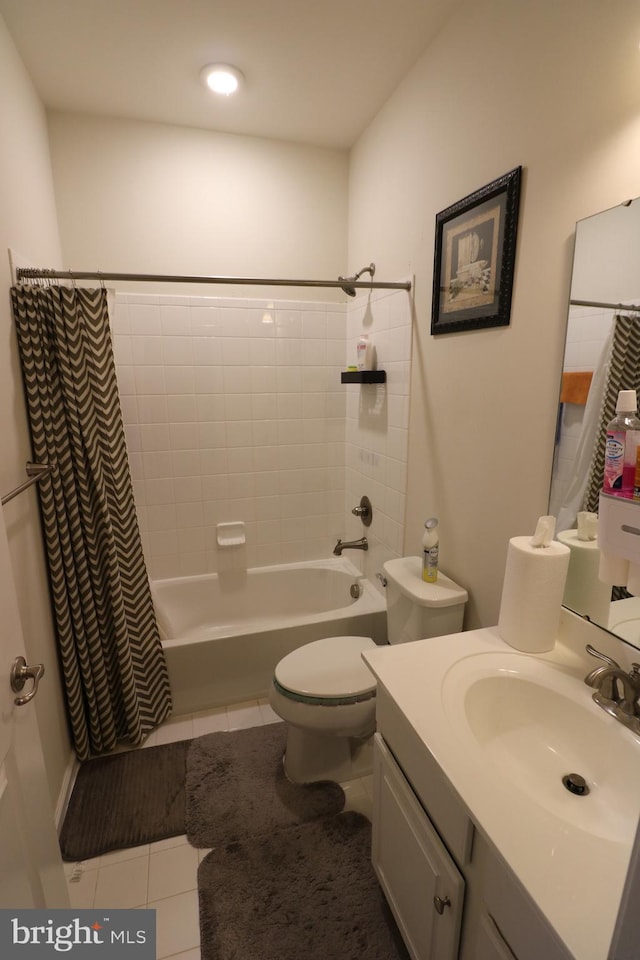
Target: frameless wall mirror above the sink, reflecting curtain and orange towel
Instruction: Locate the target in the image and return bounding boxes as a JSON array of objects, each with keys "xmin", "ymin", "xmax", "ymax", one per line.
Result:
[{"xmin": 549, "ymin": 199, "xmax": 640, "ymax": 648}]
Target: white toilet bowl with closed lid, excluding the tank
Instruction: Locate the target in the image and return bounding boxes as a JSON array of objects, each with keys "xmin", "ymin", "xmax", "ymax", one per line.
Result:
[{"xmin": 269, "ymin": 636, "xmax": 376, "ymax": 783}]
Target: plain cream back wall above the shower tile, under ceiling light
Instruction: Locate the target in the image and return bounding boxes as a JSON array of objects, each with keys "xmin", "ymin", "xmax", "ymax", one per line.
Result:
[{"xmin": 49, "ymin": 113, "xmax": 350, "ymax": 299}]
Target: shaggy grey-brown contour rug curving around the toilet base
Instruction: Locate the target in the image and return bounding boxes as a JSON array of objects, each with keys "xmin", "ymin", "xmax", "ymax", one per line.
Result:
[{"xmin": 186, "ymin": 723, "xmax": 345, "ymax": 847}]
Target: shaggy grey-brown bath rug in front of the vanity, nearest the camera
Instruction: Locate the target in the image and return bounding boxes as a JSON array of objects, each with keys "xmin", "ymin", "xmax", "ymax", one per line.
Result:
[{"xmin": 198, "ymin": 812, "xmax": 408, "ymax": 960}]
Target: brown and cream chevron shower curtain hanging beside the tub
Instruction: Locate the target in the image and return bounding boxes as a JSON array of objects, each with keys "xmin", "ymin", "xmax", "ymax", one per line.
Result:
[{"xmin": 11, "ymin": 286, "xmax": 171, "ymax": 760}]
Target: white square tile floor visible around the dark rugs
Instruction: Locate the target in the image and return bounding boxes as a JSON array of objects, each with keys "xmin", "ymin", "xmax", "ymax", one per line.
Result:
[{"xmin": 65, "ymin": 700, "xmax": 372, "ymax": 960}]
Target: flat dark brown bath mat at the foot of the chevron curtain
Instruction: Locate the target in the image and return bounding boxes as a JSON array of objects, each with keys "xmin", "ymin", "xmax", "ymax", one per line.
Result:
[{"xmin": 60, "ymin": 740, "xmax": 190, "ymax": 860}]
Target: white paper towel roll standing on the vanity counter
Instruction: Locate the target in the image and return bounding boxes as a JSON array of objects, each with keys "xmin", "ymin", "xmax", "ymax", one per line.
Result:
[{"xmin": 498, "ymin": 537, "xmax": 571, "ymax": 653}]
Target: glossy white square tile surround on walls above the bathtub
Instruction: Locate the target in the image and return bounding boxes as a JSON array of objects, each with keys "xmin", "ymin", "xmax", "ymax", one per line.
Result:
[{"xmin": 112, "ymin": 292, "xmax": 410, "ymax": 578}]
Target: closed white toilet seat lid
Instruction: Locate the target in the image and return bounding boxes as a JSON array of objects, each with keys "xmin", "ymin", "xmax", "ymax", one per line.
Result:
[{"xmin": 275, "ymin": 637, "xmax": 376, "ymax": 697}]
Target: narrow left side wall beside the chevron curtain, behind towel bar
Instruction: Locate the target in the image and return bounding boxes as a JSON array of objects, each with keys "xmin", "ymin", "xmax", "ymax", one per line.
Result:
[{"xmin": 0, "ymin": 18, "xmax": 70, "ymax": 806}]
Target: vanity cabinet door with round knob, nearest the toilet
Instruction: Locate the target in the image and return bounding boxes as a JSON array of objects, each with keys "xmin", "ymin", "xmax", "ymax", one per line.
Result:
[{"xmin": 372, "ymin": 734, "xmax": 464, "ymax": 960}]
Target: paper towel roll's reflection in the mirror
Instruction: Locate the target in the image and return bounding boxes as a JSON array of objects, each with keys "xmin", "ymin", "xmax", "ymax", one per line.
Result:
[{"xmin": 558, "ymin": 530, "xmax": 611, "ymax": 627}]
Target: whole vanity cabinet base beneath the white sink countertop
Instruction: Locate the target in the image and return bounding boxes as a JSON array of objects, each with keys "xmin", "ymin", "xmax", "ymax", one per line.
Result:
[{"xmin": 372, "ymin": 685, "xmax": 574, "ymax": 960}]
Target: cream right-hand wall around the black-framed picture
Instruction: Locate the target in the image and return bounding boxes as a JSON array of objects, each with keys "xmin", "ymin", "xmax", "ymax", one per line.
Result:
[{"xmin": 349, "ymin": 0, "xmax": 640, "ymax": 626}]
